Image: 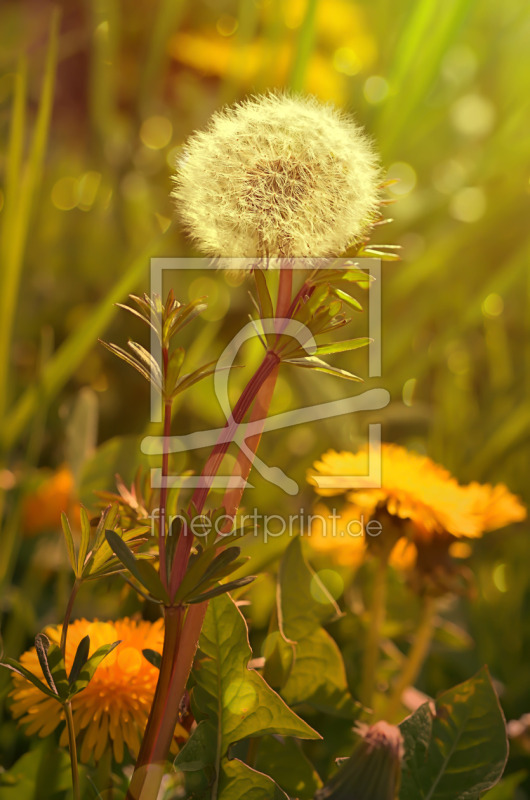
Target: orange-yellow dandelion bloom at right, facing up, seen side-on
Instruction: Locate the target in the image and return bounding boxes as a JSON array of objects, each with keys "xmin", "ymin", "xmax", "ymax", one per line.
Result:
[{"xmin": 308, "ymin": 444, "xmax": 526, "ymax": 588}]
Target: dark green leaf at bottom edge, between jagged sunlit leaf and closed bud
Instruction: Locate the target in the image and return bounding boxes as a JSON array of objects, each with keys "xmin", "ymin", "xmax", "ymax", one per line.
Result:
[{"xmin": 256, "ymin": 736, "xmax": 322, "ymax": 800}]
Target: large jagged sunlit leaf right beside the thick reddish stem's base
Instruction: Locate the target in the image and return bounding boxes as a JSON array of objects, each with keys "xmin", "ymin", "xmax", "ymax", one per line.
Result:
[{"xmin": 175, "ymin": 594, "xmax": 319, "ymax": 800}]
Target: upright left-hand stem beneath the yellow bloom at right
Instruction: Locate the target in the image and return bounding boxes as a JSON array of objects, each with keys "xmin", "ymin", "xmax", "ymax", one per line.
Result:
[{"xmin": 360, "ymin": 553, "xmax": 388, "ymax": 708}]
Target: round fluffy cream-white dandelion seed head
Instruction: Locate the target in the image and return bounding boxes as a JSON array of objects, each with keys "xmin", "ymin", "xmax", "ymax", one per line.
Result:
[{"xmin": 173, "ymin": 93, "xmax": 380, "ymax": 258}]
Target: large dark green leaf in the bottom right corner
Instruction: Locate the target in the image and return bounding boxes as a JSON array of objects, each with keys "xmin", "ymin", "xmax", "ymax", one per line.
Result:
[{"xmin": 400, "ymin": 667, "xmax": 508, "ymax": 800}]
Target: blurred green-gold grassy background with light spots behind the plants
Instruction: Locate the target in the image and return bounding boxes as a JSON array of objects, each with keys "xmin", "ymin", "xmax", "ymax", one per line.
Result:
[{"xmin": 0, "ymin": 0, "xmax": 530, "ymax": 792}]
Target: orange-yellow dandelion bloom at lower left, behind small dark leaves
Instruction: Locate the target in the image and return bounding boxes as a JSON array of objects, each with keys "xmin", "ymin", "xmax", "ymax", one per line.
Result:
[{"xmin": 11, "ymin": 617, "xmax": 186, "ymax": 763}]
